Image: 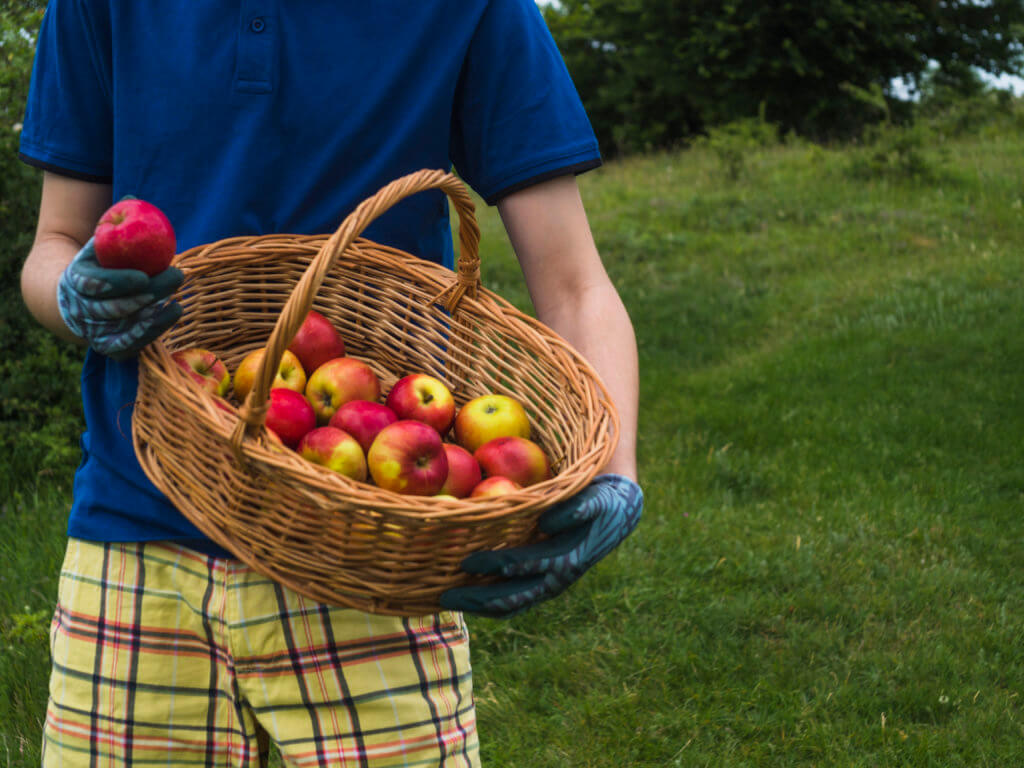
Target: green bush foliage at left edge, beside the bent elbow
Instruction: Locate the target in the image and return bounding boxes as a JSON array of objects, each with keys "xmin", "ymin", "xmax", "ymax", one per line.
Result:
[{"xmin": 0, "ymin": 2, "xmax": 82, "ymax": 483}]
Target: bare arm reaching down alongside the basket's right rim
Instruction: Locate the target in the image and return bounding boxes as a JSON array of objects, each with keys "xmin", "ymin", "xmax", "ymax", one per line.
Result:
[{"xmin": 498, "ymin": 175, "xmax": 639, "ymax": 480}]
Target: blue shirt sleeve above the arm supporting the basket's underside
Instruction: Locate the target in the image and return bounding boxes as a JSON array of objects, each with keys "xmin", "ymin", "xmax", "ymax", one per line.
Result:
[{"xmin": 451, "ymin": 0, "xmax": 601, "ymax": 205}]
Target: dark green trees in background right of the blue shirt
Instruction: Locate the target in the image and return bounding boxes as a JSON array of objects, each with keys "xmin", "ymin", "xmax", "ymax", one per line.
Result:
[{"xmin": 545, "ymin": 0, "xmax": 1024, "ymax": 154}]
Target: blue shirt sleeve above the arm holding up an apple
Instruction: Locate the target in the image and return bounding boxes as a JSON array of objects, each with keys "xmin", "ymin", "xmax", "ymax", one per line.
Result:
[{"xmin": 19, "ymin": 0, "xmax": 114, "ymax": 182}]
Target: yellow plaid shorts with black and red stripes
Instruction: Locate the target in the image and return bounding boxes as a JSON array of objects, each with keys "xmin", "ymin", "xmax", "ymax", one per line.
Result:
[{"xmin": 43, "ymin": 540, "xmax": 479, "ymax": 768}]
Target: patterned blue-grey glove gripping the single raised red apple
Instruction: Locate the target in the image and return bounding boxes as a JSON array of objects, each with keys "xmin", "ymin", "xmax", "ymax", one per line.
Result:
[{"xmin": 57, "ymin": 239, "xmax": 184, "ymax": 360}]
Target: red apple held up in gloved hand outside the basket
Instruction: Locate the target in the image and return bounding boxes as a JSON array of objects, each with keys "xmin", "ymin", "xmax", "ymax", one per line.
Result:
[{"xmin": 92, "ymin": 199, "xmax": 177, "ymax": 278}]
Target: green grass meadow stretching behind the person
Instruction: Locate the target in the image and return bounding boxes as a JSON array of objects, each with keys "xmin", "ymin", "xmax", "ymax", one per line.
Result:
[{"xmin": 6, "ymin": 117, "xmax": 1024, "ymax": 768}]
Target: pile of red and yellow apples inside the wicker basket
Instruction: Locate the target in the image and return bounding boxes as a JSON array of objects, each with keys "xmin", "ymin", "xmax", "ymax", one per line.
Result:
[{"xmin": 172, "ymin": 310, "xmax": 551, "ymax": 499}]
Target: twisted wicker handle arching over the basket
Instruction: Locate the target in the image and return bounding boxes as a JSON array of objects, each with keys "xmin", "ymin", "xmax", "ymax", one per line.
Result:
[{"xmin": 231, "ymin": 169, "xmax": 480, "ymax": 450}]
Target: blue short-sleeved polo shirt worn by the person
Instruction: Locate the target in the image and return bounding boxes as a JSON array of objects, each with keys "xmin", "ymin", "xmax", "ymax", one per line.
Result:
[{"xmin": 20, "ymin": 0, "xmax": 600, "ymax": 554}]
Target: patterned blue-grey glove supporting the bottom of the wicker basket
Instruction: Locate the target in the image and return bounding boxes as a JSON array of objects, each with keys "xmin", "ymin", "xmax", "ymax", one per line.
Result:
[{"xmin": 440, "ymin": 474, "xmax": 643, "ymax": 618}]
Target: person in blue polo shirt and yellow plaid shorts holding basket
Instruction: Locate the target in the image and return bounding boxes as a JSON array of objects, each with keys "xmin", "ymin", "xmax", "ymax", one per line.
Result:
[{"xmin": 20, "ymin": 0, "xmax": 643, "ymax": 766}]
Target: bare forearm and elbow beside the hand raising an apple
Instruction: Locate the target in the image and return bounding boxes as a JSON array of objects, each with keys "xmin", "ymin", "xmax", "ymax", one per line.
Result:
[{"xmin": 22, "ymin": 172, "xmax": 111, "ymax": 346}]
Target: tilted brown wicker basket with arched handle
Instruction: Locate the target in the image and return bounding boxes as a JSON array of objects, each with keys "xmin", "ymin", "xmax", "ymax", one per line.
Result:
[{"xmin": 133, "ymin": 171, "xmax": 617, "ymax": 615}]
